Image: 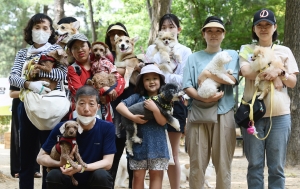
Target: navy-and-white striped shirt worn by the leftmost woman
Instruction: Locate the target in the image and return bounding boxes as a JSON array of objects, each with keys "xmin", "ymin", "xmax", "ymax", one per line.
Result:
[{"xmin": 9, "ymin": 44, "xmax": 67, "ymax": 89}]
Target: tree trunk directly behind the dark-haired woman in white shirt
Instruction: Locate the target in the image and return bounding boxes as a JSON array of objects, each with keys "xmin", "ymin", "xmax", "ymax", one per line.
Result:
[{"xmin": 147, "ymin": 0, "xmax": 172, "ymax": 45}]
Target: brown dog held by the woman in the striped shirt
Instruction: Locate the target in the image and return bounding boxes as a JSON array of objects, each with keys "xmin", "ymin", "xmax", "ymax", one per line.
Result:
[{"xmin": 25, "ymin": 49, "xmax": 68, "ymax": 90}]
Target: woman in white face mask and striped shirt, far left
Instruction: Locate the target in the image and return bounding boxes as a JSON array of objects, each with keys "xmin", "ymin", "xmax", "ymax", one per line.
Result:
[{"xmin": 9, "ymin": 13, "xmax": 67, "ymax": 189}]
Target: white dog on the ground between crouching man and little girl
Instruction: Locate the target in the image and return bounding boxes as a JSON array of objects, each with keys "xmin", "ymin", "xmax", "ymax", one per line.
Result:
[{"xmin": 115, "ymin": 154, "xmax": 149, "ymax": 189}]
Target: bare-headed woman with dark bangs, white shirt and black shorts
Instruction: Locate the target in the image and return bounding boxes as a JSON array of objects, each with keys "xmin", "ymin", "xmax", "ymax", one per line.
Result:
[{"xmin": 146, "ymin": 14, "xmax": 192, "ymax": 189}]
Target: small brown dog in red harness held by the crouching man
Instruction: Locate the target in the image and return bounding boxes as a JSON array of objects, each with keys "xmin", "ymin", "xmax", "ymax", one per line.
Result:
[{"xmin": 47, "ymin": 121, "xmax": 87, "ymax": 186}]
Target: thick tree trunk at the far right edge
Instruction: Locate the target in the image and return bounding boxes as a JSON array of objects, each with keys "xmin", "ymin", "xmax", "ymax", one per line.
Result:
[{"xmin": 284, "ymin": 0, "xmax": 300, "ymax": 166}]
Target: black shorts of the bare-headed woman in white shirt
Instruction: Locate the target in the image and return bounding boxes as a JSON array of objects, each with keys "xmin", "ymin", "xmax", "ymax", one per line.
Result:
[{"xmin": 167, "ymin": 100, "xmax": 187, "ymax": 133}]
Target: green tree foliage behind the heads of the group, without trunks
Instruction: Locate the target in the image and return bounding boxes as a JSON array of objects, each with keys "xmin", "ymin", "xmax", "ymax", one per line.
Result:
[{"xmin": 0, "ymin": 0, "xmax": 285, "ymax": 77}]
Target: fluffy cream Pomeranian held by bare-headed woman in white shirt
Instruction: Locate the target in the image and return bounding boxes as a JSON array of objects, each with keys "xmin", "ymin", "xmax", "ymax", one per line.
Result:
[{"xmin": 152, "ymin": 31, "xmax": 181, "ymax": 73}]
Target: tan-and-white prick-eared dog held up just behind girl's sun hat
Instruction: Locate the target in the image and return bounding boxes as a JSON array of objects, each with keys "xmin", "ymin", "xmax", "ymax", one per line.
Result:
[{"xmin": 115, "ymin": 35, "xmax": 140, "ymax": 88}]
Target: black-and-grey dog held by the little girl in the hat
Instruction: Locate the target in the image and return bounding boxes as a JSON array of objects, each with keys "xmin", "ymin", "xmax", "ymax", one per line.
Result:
[{"xmin": 121, "ymin": 83, "xmax": 183, "ymax": 156}]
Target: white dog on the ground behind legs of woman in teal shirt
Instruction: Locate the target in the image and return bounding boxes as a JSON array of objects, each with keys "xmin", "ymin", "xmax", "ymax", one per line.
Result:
[{"xmin": 180, "ymin": 161, "xmax": 214, "ymax": 188}]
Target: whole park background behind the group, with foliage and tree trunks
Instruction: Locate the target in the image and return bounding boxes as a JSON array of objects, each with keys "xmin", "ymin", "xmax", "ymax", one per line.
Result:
[{"xmin": 0, "ymin": 0, "xmax": 300, "ymax": 179}]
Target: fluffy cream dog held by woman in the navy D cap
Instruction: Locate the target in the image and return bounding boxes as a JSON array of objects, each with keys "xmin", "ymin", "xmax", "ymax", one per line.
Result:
[{"xmin": 250, "ymin": 46, "xmax": 286, "ymax": 100}]
